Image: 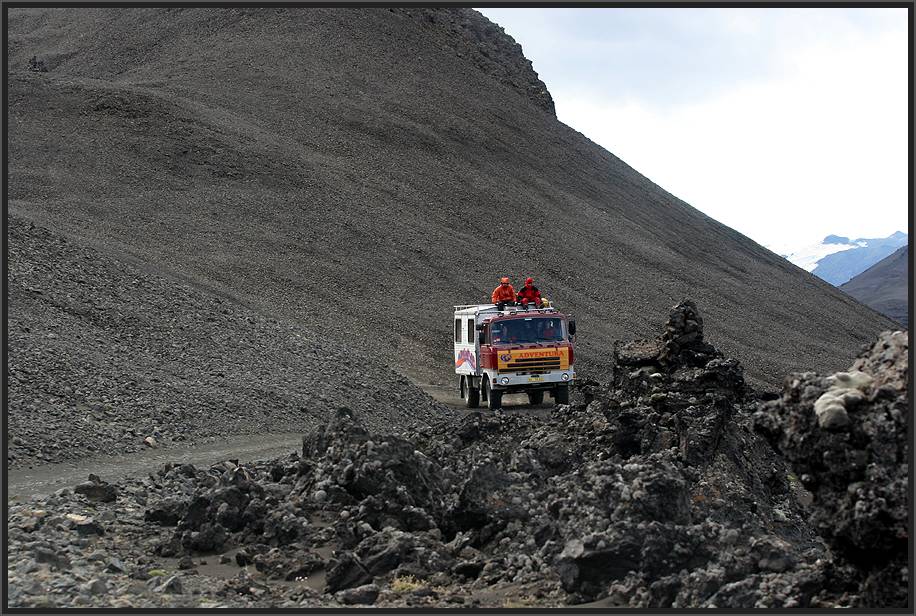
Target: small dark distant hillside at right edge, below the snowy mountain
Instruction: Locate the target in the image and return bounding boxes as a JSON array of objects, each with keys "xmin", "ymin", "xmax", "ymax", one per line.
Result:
[{"xmin": 840, "ymin": 246, "xmax": 910, "ymax": 327}]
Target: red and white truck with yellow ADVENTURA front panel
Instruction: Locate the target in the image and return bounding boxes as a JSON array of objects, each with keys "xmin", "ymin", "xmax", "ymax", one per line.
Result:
[{"xmin": 454, "ymin": 304, "xmax": 576, "ymax": 409}]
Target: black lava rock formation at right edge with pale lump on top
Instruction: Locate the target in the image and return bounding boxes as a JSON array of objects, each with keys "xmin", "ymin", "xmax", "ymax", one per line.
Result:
[{"xmin": 755, "ymin": 331, "xmax": 912, "ymax": 607}]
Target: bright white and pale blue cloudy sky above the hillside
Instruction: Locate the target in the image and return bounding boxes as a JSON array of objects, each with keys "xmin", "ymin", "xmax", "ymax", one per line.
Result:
[{"xmin": 479, "ymin": 8, "xmax": 910, "ymax": 247}]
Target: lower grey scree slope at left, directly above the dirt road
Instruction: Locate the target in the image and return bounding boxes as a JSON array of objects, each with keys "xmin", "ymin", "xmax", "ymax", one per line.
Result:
[{"xmin": 6, "ymin": 216, "xmax": 451, "ymax": 467}]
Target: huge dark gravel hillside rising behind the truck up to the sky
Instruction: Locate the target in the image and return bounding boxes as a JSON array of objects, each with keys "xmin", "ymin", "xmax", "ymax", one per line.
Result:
[{"xmin": 8, "ymin": 8, "xmax": 891, "ymax": 385}]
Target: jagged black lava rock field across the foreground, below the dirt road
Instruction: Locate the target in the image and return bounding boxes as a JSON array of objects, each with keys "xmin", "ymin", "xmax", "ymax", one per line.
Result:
[{"xmin": 8, "ymin": 302, "xmax": 906, "ymax": 608}]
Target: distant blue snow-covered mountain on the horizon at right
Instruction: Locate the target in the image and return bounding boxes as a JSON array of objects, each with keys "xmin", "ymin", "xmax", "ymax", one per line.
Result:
[{"xmin": 768, "ymin": 231, "xmax": 907, "ymax": 286}]
